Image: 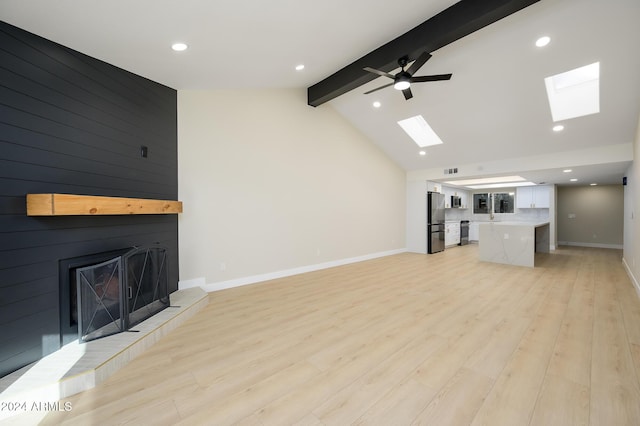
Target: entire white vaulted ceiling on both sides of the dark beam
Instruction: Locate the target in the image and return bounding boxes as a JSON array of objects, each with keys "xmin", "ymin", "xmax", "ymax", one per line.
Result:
[{"xmin": 0, "ymin": 0, "xmax": 640, "ymax": 184}]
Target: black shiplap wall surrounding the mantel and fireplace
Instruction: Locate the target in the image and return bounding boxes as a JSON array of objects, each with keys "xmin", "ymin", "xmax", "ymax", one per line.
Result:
[{"xmin": 0, "ymin": 22, "xmax": 178, "ymax": 377}]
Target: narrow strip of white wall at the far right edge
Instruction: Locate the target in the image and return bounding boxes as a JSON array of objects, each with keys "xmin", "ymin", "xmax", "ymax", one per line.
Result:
[{"xmin": 622, "ymin": 111, "xmax": 640, "ymax": 293}]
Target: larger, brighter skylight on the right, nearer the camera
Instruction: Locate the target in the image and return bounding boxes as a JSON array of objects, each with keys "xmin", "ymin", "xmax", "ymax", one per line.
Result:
[{"xmin": 544, "ymin": 62, "xmax": 600, "ymax": 121}]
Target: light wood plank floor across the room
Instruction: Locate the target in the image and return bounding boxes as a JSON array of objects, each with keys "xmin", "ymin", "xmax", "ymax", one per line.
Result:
[{"xmin": 36, "ymin": 245, "xmax": 640, "ymax": 426}]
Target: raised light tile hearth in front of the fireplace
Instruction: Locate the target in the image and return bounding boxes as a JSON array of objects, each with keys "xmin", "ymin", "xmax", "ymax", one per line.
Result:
[{"xmin": 0, "ymin": 287, "xmax": 208, "ymax": 420}]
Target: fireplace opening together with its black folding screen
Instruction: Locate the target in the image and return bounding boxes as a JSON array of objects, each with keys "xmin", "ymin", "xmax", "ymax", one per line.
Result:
[{"xmin": 60, "ymin": 245, "xmax": 169, "ymax": 345}]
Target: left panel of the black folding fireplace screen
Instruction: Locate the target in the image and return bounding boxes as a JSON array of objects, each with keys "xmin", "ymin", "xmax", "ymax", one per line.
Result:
[{"xmin": 76, "ymin": 256, "xmax": 125, "ymax": 342}]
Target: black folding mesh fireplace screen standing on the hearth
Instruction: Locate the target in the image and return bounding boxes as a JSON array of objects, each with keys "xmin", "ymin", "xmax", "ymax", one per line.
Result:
[{"xmin": 76, "ymin": 246, "xmax": 169, "ymax": 342}]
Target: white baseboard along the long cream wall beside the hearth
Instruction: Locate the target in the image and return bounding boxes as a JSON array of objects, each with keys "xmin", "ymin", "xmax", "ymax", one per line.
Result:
[{"xmin": 189, "ymin": 249, "xmax": 407, "ymax": 292}]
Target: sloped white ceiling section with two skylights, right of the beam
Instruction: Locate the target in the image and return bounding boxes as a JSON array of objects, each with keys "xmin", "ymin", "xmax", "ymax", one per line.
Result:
[{"xmin": 328, "ymin": 0, "xmax": 640, "ymax": 184}]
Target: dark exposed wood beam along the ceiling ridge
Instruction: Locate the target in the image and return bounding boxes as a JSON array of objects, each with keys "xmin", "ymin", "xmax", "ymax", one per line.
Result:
[{"xmin": 307, "ymin": 0, "xmax": 539, "ymax": 106}]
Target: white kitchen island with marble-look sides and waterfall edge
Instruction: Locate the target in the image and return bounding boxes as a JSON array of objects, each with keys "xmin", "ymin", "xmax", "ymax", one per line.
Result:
[{"xmin": 478, "ymin": 222, "xmax": 550, "ymax": 267}]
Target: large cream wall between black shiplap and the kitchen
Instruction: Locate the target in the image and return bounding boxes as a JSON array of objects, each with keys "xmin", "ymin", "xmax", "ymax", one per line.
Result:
[{"xmin": 178, "ymin": 89, "xmax": 406, "ymax": 289}]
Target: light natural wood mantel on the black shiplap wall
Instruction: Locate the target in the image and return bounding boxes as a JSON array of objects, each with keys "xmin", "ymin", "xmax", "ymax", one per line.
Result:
[{"xmin": 27, "ymin": 194, "xmax": 182, "ymax": 216}]
